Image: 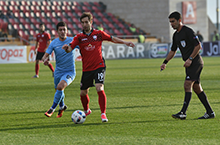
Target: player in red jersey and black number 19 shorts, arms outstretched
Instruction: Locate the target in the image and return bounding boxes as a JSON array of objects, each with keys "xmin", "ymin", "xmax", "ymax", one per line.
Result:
[{"xmin": 62, "ymin": 12, "xmax": 135, "ymax": 122}]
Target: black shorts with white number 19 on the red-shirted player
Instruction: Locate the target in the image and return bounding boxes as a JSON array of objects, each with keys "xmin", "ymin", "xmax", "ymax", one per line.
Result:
[{"xmin": 80, "ymin": 67, "xmax": 106, "ymax": 90}]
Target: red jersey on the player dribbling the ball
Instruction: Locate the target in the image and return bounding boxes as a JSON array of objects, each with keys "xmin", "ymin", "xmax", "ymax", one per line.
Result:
[{"xmin": 70, "ymin": 29, "xmax": 112, "ymax": 72}]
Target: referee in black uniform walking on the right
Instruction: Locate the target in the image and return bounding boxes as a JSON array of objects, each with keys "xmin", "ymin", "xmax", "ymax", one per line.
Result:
[{"xmin": 160, "ymin": 12, "xmax": 215, "ymax": 120}]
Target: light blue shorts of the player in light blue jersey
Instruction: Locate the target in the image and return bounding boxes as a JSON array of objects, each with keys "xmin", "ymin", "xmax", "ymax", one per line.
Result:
[{"xmin": 54, "ymin": 71, "xmax": 76, "ymax": 89}]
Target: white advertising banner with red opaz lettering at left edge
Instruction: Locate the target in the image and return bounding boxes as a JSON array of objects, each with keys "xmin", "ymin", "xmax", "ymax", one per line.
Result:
[{"xmin": 0, "ymin": 46, "xmax": 27, "ymax": 63}]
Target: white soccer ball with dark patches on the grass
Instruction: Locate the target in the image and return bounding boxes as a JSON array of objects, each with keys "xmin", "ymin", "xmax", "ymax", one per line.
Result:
[{"xmin": 71, "ymin": 110, "xmax": 86, "ymax": 124}]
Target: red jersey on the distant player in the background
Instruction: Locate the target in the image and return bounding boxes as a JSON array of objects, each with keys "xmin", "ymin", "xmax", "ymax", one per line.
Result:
[{"xmin": 36, "ymin": 31, "xmax": 51, "ymax": 52}]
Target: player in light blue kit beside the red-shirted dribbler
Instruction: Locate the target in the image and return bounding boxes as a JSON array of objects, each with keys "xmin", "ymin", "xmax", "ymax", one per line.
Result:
[{"xmin": 42, "ymin": 22, "xmax": 76, "ymax": 118}]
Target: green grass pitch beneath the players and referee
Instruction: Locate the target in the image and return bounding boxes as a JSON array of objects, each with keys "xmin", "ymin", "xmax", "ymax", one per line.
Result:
[{"xmin": 0, "ymin": 57, "xmax": 220, "ymax": 145}]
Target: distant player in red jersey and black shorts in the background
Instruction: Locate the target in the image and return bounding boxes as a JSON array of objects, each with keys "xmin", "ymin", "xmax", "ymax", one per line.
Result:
[{"xmin": 33, "ymin": 24, "xmax": 54, "ymax": 78}]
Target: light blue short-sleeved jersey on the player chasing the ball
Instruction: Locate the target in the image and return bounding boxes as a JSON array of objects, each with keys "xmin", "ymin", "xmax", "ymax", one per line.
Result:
[{"xmin": 46, "ymin": 37, "xmax": 78, "ymax": 73}]
